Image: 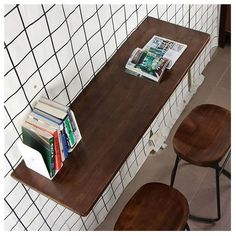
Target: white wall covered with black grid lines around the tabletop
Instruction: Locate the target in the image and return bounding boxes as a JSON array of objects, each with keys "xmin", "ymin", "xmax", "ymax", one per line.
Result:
[{"xmin": 4, "ymin": 4, "xmax": 218, "ymax": 230}]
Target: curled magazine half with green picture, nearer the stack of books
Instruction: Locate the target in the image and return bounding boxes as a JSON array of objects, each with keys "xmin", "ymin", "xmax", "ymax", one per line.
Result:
[{"xmin": 126, "ymin": 48, "xmax": 169, "ymax": 81}]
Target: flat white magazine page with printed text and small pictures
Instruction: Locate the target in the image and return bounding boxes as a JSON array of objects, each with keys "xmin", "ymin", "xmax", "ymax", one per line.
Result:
[{"xmin": 143, "ymin": 35, "xmax": 187, "ymax": 69}]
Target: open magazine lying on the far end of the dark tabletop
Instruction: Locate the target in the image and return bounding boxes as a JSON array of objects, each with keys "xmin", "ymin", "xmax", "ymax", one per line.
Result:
[{"xmin": 125, "ymin": 36, "xmax": 187, "ymax": 82}]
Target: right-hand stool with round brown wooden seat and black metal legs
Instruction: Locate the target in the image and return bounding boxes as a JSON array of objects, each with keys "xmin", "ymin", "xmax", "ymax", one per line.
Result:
[{"xmin": 170, "ymin": 104, "xmax": 230, "ymax": 223}]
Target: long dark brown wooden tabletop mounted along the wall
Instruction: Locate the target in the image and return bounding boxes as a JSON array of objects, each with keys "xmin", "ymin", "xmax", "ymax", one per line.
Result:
[{"xmin": 12, "ymin": 17, "xmax": 210, "ymax": 216}]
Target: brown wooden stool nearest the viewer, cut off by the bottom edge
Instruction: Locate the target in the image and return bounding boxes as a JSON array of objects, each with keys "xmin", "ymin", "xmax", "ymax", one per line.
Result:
[{"xmin": 115, "ymin": 183, "xmax": 189, "ymax": 230}]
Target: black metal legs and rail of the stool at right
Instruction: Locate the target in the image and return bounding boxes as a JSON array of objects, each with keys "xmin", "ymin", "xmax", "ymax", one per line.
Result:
[{"xmin": 170, "ymin": 152, "xmax": 231, "ymax": 223}]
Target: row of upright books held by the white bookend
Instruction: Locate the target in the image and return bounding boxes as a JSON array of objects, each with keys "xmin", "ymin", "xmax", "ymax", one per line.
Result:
[{"xmin": 22, "ymin": 98, "xmax": 82, "ymax": 178}]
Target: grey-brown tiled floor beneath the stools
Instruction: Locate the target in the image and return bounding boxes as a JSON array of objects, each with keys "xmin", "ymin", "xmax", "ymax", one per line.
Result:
[{"xmin": 97, "ymin": 46, "xmax": 231, "ymax": 230}]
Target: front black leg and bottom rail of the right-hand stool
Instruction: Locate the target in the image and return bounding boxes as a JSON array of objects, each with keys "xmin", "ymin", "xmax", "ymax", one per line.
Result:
[{"xmin": 189, "ymin": 168, "xmax": 221, "ymax": 223}]
